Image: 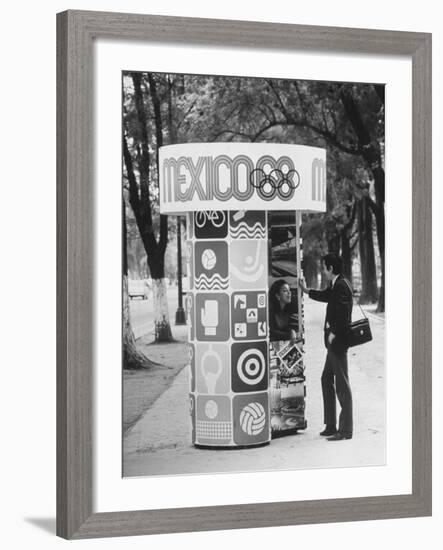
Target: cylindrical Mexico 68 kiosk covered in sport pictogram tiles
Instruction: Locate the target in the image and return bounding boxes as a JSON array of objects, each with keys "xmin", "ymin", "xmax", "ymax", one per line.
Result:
[{"xmin": 159, "ymin": 143, "xmax": 326, "ymax": 447}]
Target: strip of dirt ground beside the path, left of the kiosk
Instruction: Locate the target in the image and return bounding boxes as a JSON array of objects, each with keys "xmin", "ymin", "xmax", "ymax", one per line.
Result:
[{"xmin": 123, "ymin": 327, "xmax": 188, "ymax": 435}]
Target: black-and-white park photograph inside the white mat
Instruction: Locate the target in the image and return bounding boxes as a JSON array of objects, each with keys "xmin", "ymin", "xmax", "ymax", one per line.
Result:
[{"xmin": 121, "ymin": 71, "xmax": 386, "ymax": 477}]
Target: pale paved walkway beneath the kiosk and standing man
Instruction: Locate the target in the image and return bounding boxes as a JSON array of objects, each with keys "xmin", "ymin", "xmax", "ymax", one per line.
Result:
[{"xmin": 124, "ymin": 300, "xmax": 385, "ymax": 476}]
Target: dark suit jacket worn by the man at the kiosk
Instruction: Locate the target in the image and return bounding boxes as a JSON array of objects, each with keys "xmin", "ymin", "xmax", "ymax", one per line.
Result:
[{"xmin": 309, "ymin": 275, "xmax": 352, "ymax": 351}]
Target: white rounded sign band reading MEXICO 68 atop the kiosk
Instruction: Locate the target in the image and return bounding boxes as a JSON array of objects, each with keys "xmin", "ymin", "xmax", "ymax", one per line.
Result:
[{"xmin": 159, "ymin": 143, "xmax": 326, "ymax": 214}]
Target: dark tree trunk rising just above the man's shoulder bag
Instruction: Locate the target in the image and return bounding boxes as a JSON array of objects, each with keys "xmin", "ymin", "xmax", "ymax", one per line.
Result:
[{"xmin": 358, "ymin": 196, "xmax": 377, "ymax": 304}]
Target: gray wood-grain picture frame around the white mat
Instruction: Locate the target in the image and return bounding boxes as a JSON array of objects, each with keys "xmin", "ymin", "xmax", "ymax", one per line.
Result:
[{"xmin": 57, "ymin": 11, "xmax": 432, "ymax": 539}]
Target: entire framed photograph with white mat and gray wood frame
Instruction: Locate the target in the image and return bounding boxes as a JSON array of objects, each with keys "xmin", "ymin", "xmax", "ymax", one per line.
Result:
[{"xmin": 57, "ymin": 11, "xmax": 432, "ymax": 539}]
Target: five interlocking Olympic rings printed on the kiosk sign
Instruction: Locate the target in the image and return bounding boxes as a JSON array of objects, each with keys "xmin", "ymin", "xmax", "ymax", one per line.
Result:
[{"xmin": 249, "ymin": 168, "xmax": 300, "ymax": 201}]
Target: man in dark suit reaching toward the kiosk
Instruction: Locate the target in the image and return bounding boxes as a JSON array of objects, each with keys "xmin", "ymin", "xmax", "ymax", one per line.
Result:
[{"xmin": 299, "ymin": 254, "xmax": 353, "ymax": 441}]
